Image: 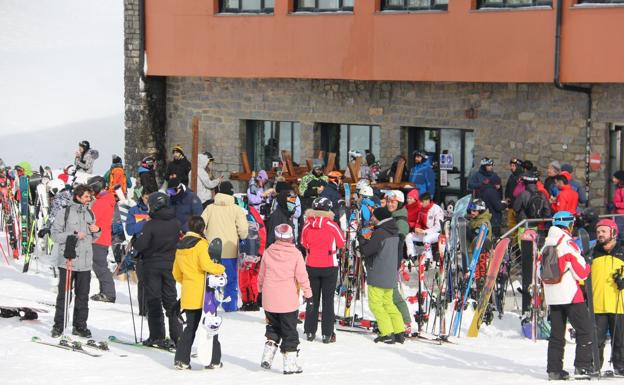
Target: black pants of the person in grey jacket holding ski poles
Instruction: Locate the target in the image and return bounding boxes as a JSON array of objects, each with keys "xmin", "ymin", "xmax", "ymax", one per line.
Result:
[{"xmin": 54, "ymin": 267, "xmax": 91, "ymax": 329}]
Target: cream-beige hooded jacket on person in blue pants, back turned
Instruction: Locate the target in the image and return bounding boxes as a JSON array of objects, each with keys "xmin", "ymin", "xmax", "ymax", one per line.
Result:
[{"xmin": 202, "ymin": 193, "xmax": 249, "ymax": 259}]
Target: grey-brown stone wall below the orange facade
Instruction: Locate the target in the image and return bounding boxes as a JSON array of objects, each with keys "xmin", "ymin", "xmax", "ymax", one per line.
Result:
[{"xmin": 166, "ymin": 77, "xmax": 624, "ymax": 206}]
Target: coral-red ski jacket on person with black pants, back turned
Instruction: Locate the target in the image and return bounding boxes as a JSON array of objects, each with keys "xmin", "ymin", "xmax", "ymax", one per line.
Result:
[{"xmin": 301, "ymin": 209, "xmax": 345, "ymax": 267}]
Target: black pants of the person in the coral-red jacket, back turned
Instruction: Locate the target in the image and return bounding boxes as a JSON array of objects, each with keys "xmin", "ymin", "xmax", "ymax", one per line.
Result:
[{"xmin": 303, "ymin": 266, "xmax": 338, "ymax": 336}]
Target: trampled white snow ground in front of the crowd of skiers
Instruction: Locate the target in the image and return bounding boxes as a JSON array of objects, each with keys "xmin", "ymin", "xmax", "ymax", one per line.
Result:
[{"xmin": 0, "ymin": 243, "xmax": 596, "ymax": 385}]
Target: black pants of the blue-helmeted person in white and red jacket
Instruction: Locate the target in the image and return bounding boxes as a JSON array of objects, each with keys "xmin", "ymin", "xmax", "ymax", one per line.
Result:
[{"xmin": 546, "ymin": 303, "xmax": 592, "ymax": 373}]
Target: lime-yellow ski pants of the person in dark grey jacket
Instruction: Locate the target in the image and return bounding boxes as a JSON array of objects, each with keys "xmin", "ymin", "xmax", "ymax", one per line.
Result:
[{"xmin": 368, "ymin": 285, "xmax": 405, "ymax": 336}]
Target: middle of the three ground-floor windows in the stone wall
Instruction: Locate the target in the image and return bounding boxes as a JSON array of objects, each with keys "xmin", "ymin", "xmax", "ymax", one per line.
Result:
[{"xmin": 321, "ymin": 124, "xmax": 381, "ymax": 169}]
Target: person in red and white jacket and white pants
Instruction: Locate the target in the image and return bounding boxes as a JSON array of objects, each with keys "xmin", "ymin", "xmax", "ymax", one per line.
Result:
[{"xmin": 405, "ymin": 192, "xmax": 444, "ymax": 261}]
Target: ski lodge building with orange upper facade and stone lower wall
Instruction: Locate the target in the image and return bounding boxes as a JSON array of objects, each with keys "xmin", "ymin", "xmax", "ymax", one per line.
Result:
[{"xmin": 124, "ymin": 0, "xmax": 624, "ymax": 207}]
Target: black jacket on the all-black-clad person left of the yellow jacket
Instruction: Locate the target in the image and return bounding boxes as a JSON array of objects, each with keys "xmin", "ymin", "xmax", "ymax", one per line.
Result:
[{"xmin": 132, "ymin": 207, "xmax": 182, "ymax": 269}]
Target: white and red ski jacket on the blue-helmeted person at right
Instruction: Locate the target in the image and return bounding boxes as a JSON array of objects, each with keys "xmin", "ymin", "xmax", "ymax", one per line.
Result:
[{"xmin": 540, "ymin": 226, "xmax": 590, "ymax": 305}]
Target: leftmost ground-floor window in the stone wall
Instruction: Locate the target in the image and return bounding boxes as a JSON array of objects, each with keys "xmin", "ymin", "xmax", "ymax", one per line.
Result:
[{"xmin": 247, "ymin": 120, "xmax": 301, "ymax": 170}]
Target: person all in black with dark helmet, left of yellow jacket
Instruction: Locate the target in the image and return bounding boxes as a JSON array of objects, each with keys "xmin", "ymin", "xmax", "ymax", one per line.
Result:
[{"xmin": 134, "ymin": 192, "xmax": 182, "ymax": 348}]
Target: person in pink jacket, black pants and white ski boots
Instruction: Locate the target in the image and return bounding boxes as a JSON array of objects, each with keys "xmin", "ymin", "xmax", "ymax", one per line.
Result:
[{"xmin": 258, "ymin": 223, "xmax": 312, "ymax": 374}]
